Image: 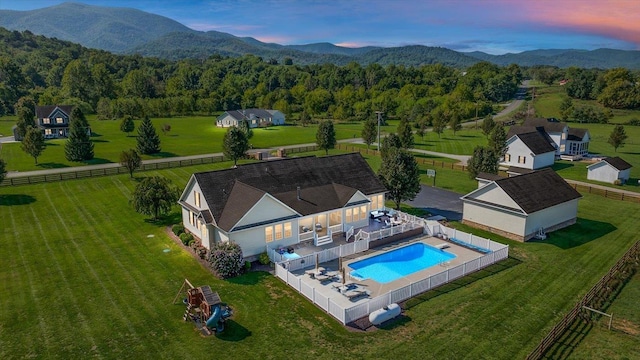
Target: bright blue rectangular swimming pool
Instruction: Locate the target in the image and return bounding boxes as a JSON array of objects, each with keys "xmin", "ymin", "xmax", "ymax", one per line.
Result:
[{"xmin": 349, "ymin": 243, "xmax": 456, "ymax": 284}]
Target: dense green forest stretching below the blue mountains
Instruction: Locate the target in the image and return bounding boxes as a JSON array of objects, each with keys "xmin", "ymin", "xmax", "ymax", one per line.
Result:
[{"xmin": 0, "ymin": 28, "xmax": 640, "ymax": 125}]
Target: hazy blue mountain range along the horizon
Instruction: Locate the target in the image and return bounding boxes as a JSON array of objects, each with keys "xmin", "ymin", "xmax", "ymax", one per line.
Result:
[{"xmin": 0, "ymin": 2, "xmax": 640, "ymax": 69}]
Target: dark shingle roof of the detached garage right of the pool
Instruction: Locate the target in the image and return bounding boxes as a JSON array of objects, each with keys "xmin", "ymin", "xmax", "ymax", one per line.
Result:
[{"xmin": 495, "ymin": 169, "xmax": 582, "ymax": 214}]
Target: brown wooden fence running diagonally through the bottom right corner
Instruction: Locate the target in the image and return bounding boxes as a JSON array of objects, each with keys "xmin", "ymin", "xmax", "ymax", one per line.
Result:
[{"xmin": 527, "ymin": 241, "xmax": 640, "ymax": 360}]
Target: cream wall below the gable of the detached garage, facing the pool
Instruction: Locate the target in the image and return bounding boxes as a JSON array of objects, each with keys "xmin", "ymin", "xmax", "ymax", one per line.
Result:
[{"xmin": 462, "ymin": 201, "xmax": 526, "ymax": 235}]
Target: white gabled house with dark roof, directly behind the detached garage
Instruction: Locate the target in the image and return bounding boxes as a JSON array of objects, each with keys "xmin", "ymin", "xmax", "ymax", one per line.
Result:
[{"xmin": 500, "ymin": 130, "xmax": 555, "ymax": 170}]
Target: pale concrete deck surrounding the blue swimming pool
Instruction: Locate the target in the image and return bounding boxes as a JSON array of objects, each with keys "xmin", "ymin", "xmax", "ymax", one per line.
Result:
[{"xmin": 293, "ymin": 236, "xmax": 484, "ymax": 308}]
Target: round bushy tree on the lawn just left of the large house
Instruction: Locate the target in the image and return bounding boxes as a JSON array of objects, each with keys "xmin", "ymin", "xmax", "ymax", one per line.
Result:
[{"xmin": 131, "ymin": 176, "xmax": 180, "ymax": 220}]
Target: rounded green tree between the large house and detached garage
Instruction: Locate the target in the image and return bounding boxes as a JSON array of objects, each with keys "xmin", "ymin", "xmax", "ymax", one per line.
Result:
[{"xmin": 378, "ymin": 148, "xmax": 420, "ymax": 210}]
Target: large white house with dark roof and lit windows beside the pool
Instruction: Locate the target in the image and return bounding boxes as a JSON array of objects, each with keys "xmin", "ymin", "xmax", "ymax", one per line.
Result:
[{"xmin": 178, "ymin": 153, "xmax": 387, "ymax": 257}]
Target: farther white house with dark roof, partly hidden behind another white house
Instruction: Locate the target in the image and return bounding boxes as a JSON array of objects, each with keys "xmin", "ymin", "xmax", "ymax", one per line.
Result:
[{"xmin": 507, "ymin": 118, "xmax": 591, "ymax": 156}]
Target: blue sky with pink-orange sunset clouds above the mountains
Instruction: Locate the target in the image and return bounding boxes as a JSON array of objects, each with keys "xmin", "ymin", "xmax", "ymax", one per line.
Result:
[{"xmin": 0, "ymin": 0, "xmax": 640, "ymax": 54}]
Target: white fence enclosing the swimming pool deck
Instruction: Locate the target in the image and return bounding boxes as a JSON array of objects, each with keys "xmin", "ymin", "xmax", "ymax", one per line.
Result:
[{"xmin": 275, "ymin": 223, "xmax": 509, "ymax": 324}]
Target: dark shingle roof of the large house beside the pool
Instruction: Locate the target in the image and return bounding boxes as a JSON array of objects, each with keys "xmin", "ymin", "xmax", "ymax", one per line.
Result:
[{"xmin": 194, "ymin": 153, "xmax": 386, "ymax": 231}]
